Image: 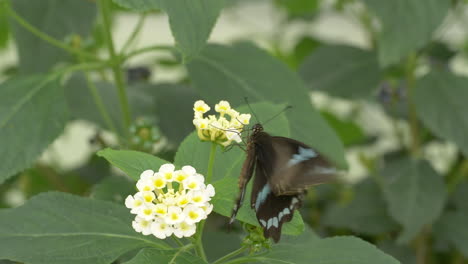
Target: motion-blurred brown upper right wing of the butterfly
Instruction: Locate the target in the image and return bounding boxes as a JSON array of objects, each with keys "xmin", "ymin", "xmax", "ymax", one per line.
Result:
[{"xmin": 267, "ymin": 137, "xmax": 336, "ymax": 195}]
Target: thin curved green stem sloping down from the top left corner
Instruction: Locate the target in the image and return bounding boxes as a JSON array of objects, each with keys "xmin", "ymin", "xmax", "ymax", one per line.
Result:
[{"xmin": 5, "ymin": 5, "xmax": 99, "ymax": 61}]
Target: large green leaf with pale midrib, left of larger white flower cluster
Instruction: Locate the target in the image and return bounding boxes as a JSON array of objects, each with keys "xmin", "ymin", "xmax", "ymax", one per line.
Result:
[{"xmin": 0, "ymin": 192, "xmax": 169, "ymax": 264}]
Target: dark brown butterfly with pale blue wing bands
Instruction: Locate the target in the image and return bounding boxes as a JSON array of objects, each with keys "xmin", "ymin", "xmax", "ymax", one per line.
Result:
[{"xmin": 229, "ymin": 124, "xmax": 336, "ymax": 243}]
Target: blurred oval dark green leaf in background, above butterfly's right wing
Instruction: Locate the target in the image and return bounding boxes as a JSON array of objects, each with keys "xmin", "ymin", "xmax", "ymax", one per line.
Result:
[{"xmin": 299, "ymin": 46, "xmax": 383, "ymax": 98}]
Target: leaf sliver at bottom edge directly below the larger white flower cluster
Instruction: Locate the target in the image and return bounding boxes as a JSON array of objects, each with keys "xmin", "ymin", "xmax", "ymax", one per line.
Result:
[{"xmin": 124, "ymin": 248, "xmax": 207, "ymax": 264}]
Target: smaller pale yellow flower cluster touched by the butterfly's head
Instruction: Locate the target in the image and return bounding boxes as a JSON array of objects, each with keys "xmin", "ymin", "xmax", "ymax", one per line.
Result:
[{"xmin": 193, "ymin": 100, "xmax": 250, "ymax": 146}]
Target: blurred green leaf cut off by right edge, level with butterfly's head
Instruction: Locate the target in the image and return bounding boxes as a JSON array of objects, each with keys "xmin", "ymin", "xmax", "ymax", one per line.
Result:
[{"xmin": 414, "ymin": 71, "xmax": 468, "ymax": 157}]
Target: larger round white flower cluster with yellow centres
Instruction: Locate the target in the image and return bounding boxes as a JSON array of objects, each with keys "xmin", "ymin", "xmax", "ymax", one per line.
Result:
[{"xmin": 125, "ymin": 164, "xmax": 215, "ymax": 239}]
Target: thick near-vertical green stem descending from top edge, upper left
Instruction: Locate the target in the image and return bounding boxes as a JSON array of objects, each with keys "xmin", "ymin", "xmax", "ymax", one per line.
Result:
[{"xmin": 99, "ymin": 0, "xmax": 131, "ymax": 139}]
